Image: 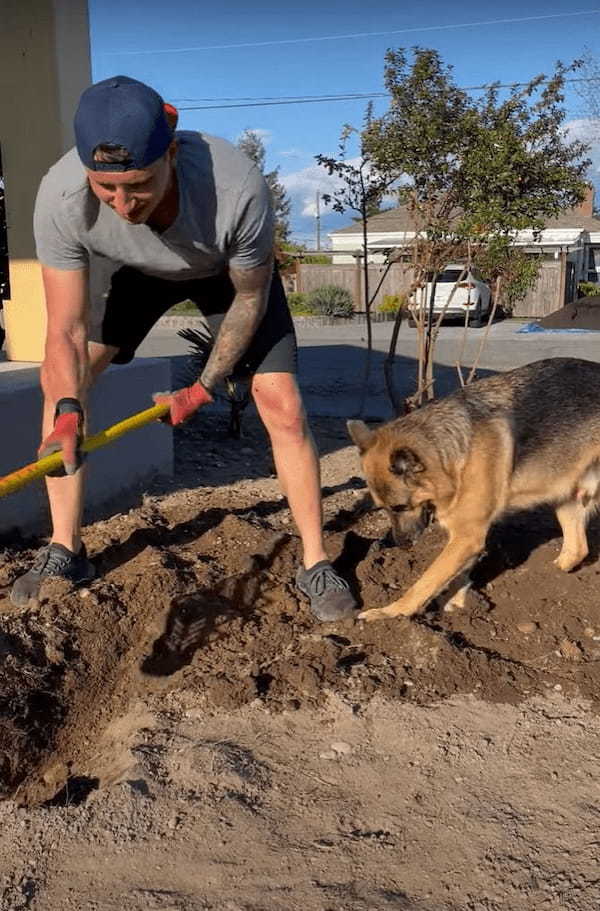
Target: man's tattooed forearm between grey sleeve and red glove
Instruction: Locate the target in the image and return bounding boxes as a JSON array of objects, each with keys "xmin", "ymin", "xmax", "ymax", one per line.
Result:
[{"xmin": 200, "ymin": 260, "xmax": 273, "ymax": 392}]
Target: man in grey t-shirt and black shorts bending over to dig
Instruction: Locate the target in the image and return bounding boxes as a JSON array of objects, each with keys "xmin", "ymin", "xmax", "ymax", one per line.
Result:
[{"xmin": 11, "ymin": 76, "xmax": 356, "ymax": 620}]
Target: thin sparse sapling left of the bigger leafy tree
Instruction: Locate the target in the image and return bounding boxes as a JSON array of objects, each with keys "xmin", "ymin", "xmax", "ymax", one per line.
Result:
[{"xmin": 315, "ymin": 104, "xmax": 390, "ymax": 417}]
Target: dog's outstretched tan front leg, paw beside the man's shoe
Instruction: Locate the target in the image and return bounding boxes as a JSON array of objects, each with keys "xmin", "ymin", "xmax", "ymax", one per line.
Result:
[{"xmin": 358, "ymin": 523, "xmax": 488, "ymax": 621}]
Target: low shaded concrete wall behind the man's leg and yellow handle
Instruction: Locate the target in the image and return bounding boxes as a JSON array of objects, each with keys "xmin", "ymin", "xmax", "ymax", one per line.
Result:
[{"xmin": 0, "ymin": 358, "xmax": 173, "ymax": 534}]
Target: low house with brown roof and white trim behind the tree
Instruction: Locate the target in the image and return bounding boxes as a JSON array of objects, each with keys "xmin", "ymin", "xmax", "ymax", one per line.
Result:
[{"xmin": 329, "ymin": 187, "xmax": 600, "ymax": 317}]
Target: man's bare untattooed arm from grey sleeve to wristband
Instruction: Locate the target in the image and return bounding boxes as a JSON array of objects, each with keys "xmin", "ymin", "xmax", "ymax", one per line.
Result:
[{"xmin": 41, "ymin": 266, "xmax": 89, "ymax": 404}]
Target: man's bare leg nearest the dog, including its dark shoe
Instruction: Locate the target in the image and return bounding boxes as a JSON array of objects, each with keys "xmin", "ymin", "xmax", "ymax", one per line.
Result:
[{"xmin": 252, "ymin": 373, "xmax": 356, "ymax": 620}]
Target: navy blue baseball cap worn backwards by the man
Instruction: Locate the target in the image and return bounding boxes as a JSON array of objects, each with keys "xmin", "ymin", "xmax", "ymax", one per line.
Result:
[{"xmin": 74, "ymin": 76, "xmax": 173, "ymax": 171}]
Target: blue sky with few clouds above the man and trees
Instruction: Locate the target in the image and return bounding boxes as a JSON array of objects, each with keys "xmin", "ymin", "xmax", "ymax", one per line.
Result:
[{"xmin": 89, "ymin": 0, "xmax": 600, "ymax": 246}]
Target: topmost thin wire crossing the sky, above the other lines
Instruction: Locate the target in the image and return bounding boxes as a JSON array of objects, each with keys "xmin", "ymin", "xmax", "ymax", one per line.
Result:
[{"xmin": 101, "ymin": 9, "xmax": 600, "ymax": 57}]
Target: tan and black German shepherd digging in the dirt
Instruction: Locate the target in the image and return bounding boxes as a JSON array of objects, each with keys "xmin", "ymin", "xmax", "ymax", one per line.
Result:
[{"xmin": 347, "ymin": 358, "xmax": 600, "ymax": 620}]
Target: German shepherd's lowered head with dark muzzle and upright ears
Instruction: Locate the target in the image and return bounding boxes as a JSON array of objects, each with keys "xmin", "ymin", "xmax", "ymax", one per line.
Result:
[{"xmin": 346, "ymin": 421, "xmax": 434, "ymax": 544}]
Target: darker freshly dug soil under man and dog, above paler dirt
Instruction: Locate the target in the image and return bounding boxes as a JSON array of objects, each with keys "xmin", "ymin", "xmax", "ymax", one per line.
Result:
[{"xmin": 0, "ymin": 452, "xmax": 600, "ymax": 803}]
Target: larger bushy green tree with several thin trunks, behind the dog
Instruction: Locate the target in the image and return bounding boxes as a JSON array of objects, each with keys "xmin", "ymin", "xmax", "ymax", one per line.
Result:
[{"xmin": 363, "ymin": 48, "xmax": 589, "ymax": 404}]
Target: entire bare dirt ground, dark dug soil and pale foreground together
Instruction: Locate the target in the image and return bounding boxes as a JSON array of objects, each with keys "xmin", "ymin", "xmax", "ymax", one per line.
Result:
[{"xmin": 0, "ymin": 414, "xmax": 600, "ymax": 911}]
